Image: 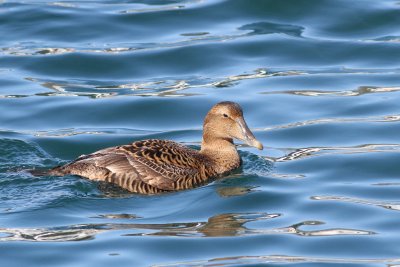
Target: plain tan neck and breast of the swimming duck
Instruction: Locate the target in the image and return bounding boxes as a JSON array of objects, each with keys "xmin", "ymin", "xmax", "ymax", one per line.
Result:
[{"xmin": 200, "ymin": 135, "xmax": 240, "ymax": 174}]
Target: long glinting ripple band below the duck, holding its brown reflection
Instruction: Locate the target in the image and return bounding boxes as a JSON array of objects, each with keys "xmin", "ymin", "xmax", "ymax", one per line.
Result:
[{"xmin": 0, "ymin": 213, "xmax": 374, "ymax": 242}]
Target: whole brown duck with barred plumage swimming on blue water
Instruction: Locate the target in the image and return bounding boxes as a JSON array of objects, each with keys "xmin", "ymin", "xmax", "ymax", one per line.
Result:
[{"xmin": 47, "ymin": 102, "xmax": 263, "ymax": 194}]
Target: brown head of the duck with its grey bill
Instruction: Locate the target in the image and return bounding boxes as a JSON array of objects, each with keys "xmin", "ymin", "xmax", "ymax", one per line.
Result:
[{"xmin": 203, "ymin": 101, "xmax": 263, "ymax": 150}]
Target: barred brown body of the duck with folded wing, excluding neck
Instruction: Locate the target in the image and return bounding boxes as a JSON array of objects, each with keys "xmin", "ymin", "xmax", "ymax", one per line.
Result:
[{"xmin": 59, "ymin": 140, "xmax": 201, "ymax": 193}]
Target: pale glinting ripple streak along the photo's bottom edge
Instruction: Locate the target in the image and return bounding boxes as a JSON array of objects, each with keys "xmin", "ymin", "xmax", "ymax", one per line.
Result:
[{"xmin": 153, "ymin": 255, "xmax": 400, "ymax": 267}]
